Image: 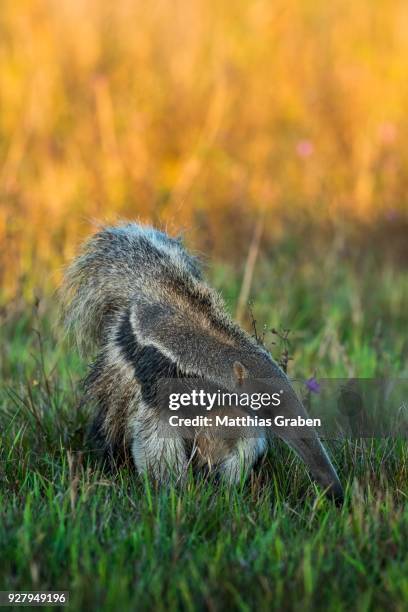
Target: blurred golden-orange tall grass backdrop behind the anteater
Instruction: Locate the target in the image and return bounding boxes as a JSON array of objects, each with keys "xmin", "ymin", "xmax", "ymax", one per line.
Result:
[{"xmin": 0, "ymin": 0, "xmax": 408, "ymax": 293}]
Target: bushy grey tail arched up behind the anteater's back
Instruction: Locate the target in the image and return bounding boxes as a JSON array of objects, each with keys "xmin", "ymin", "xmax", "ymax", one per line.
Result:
[{"xmin": 61, "ymin": 223, "xmax": 201, "ymax": 353}]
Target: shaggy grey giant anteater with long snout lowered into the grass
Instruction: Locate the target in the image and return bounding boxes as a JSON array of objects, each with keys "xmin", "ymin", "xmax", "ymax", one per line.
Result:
[{"xmin": 62, "ymin": 223, "xmax": 342, "ymax": 500}]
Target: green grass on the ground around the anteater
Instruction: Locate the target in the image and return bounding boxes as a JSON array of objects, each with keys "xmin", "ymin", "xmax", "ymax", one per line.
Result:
[{"xmin": 0, "ymin": 252, "xmax": 408, "ymax": 611}]
